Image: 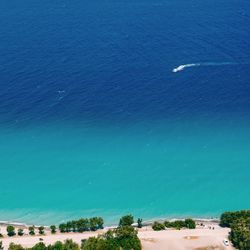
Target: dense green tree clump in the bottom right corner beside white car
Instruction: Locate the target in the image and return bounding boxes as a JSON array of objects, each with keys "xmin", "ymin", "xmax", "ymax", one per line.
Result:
[{"xmin": 220, "ymin": 210, "xmax": 250, "ymax": 250}]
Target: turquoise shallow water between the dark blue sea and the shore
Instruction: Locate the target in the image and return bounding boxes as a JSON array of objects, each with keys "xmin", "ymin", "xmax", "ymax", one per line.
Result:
[{"xmin": 0, "ymin": 120, "xmax": 250, "ymax": 224}]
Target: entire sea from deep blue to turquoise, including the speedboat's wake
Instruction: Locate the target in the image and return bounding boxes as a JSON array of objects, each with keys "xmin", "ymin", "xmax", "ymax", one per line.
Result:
[{"xmin": 0, "ymin": 0, "xmax": 250, "ymax": 225}]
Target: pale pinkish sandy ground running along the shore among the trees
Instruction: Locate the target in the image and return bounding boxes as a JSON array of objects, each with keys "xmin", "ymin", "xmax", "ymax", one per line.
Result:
[{"xmin": 0, "ymin": 223, "xmax": 234, "ymax": 250}]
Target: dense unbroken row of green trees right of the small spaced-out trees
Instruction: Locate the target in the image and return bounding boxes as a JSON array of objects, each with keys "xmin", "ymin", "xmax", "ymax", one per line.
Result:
[{"xmin": 58, "ymin": 217, "xmax": 104, "ymax": 233}]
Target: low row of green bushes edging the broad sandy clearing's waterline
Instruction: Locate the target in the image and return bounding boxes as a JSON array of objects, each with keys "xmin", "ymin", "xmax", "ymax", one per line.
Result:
[{"xmin": 152, "ymin": 219, "xmax": 196, "ymax": 231}]
